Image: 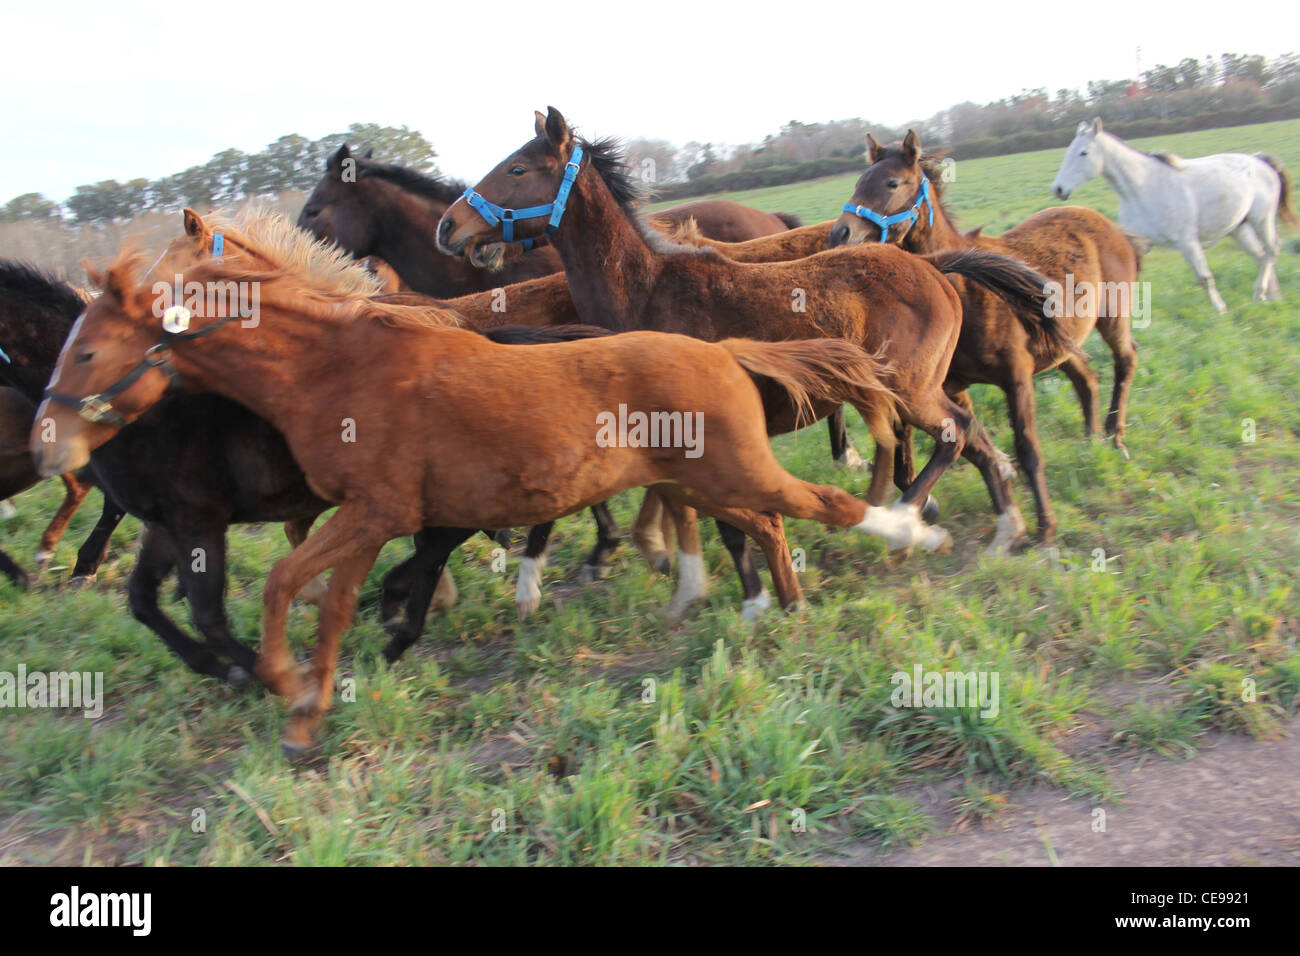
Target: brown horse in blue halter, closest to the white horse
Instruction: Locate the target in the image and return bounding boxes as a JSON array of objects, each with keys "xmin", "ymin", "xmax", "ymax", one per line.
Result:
[{"xmin": 828, "ymin": 130, "xmax": 1140, "ymax": 544}]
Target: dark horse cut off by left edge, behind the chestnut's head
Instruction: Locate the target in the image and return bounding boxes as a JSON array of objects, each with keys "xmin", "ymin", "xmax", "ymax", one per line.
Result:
[{"xmin": 0, "ymin": 260, "xmax": 112, "ymax": 588}]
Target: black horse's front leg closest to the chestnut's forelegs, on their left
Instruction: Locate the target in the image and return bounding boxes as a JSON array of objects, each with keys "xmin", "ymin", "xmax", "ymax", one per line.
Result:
[{"xmin": 172, "ymin": 522, "xmax": 257, "ymax": 684}]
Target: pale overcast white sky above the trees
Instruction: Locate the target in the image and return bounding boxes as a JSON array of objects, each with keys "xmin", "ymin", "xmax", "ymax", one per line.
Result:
[{"xmin": 0, "ymin": 0, "xmax": 1300, "ymax": 202}]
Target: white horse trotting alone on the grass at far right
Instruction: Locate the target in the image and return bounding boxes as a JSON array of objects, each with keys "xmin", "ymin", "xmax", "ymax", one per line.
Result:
[{"xmin": 1052, "ymin": 120, "xmax": 1300, "ymax": 312}]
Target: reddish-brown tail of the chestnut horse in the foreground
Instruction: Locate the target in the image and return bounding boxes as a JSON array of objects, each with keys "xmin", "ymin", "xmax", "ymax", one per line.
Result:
[{"xmin": 718, "ymin": 338, "xmax": 898, "ymax": 449}]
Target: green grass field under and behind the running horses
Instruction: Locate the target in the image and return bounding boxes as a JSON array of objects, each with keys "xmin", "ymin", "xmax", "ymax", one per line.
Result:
[{"xmin": 0, "ymin": 122, "xmax": 1300, "ymax": 864}]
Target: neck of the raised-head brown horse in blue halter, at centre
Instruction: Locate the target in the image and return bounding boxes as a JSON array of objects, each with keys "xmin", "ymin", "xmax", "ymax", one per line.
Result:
[{"xmin": 551, "ymin": 168, "xmax": 660, "ymax": 330}]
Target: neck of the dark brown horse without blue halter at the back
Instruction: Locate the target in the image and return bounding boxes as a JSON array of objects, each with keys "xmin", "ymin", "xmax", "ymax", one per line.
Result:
[{"xmin": 367, "ymin": 183, "xmax": 482, "ymax": 298}]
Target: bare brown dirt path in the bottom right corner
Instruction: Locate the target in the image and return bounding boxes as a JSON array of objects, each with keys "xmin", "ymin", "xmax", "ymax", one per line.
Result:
[{"xmin": 837, "ymin": 721, "xmax": 1300, "ymax": 866}]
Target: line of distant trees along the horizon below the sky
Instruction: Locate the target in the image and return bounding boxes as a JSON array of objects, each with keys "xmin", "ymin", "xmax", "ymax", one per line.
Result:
[{"xmin": 0, "ymin": 53, "xmax": 1300, "ymax": 222}]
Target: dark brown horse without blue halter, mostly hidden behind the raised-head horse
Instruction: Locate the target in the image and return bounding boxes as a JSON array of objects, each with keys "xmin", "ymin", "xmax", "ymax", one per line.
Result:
[{"xmin": 298, "ymin": 143, "xmax": 798, "ymax": 299}]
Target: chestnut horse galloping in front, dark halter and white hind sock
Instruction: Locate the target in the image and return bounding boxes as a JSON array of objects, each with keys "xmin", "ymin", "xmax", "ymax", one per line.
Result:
[{"xmin": 31, "ymin": 239, "xmax": 935, "ymax": 756}]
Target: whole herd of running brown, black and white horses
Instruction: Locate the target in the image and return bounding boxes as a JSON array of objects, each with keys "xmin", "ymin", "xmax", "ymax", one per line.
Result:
[{"xmin": 0, "ymin": 109, "xmax": 1294, "ymax": 756}]
